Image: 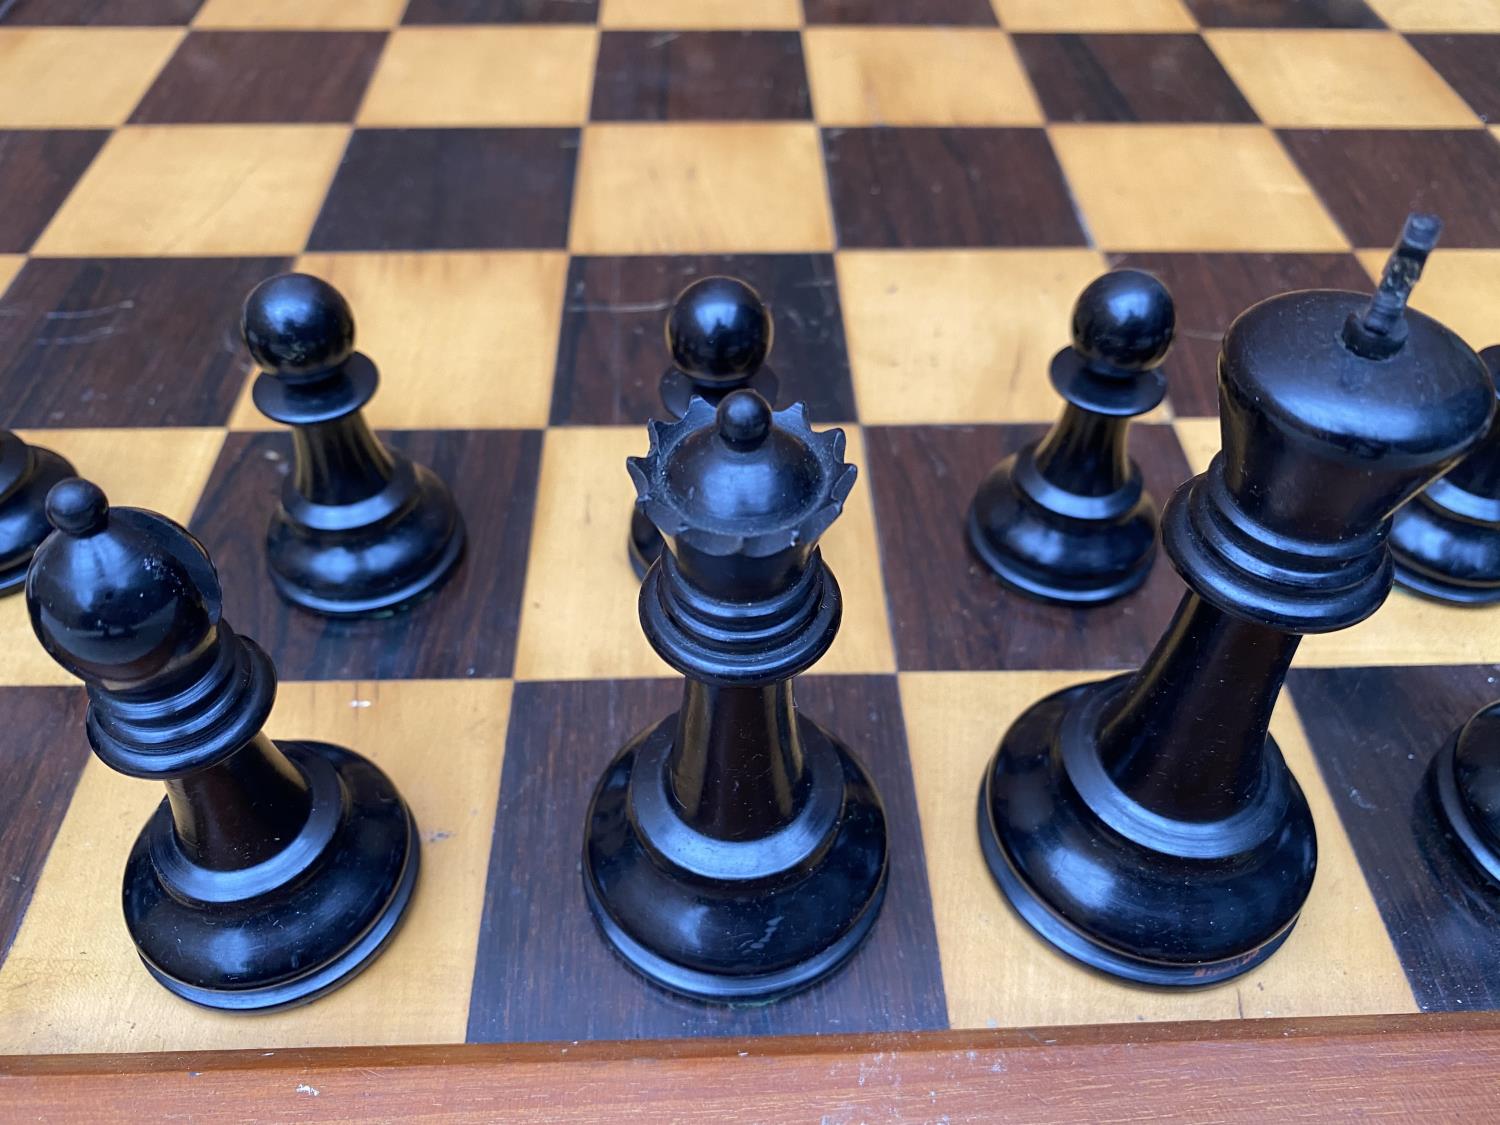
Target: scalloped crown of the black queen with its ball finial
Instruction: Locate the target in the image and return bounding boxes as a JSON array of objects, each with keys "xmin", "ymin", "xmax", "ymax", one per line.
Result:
[{"xmin": 626, "ymin": 390, "xmax": 857, "ymax": 558}]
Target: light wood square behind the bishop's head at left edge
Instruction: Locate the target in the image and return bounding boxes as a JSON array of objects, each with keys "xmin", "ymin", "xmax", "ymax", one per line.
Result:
[{"xmin": 0, "ymin": 428, "xmax": 224, "ymax": 684}]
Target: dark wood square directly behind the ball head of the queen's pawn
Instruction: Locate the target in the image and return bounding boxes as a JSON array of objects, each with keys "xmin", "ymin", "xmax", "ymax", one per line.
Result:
[{"xmin": 552, "ymin": 254, "xmax": 855, "ymax": 426}]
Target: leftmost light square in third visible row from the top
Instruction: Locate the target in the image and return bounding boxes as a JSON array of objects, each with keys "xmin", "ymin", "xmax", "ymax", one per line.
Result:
[{"xmin": 33, "ymin": 125, "xmax": 350, "ymax": 257}]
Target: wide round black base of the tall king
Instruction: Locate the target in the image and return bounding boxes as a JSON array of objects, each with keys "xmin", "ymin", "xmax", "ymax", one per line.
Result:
[{"xmin": 978, "ymin": 677, "xmax": 1317, "ymax": 987}]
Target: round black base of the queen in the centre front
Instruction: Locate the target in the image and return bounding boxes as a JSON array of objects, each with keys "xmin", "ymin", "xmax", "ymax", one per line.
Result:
[{"xmin": 584, "ymin": 714, "xmax": 888, "ymax": 1004}]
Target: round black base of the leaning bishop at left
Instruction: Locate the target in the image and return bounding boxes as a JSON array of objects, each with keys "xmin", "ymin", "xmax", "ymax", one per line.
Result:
[{"xmin": 125, "ymin": 743, "xmax": 420, "ymax": 1011}]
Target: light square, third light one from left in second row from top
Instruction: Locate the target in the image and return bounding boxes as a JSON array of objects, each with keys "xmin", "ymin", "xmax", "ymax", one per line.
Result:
[{"xmin": 803, "ymin": 27, "xmax": 1044, "ymax": 126}]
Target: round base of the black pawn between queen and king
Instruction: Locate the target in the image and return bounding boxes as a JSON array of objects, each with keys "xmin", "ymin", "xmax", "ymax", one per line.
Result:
[{"xmin": 968, "ymin": 450, "xmax": 1157, "ymax": 606}]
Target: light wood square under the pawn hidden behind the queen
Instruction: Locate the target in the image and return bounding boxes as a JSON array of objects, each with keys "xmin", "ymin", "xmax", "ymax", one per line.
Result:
[{"xmin": 516, "ymin": 426, "xmax": 896, "ymax": 680}]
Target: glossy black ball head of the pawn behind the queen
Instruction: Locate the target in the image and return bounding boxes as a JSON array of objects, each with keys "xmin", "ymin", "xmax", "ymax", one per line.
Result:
[{"xmin": 666, "ymin": 278, "xmax": 773, "ymax": 383}]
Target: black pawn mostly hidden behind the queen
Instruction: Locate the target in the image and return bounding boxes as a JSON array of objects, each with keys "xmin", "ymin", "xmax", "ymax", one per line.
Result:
[{"xmin": 630, "ymin": 276, "xmax": 777, "ymax": 578}]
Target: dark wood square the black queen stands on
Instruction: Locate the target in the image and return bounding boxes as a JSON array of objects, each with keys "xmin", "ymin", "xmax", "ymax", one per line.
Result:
[{"xmin": 468, "ymin": 677, "xmax": 942, "ymax": 1041}]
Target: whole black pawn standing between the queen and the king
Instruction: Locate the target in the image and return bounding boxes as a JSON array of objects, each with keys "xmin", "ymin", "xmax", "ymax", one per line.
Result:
[{"xmin": 969, "ymin": 270, "xmax": 1176, "ymax": 605}]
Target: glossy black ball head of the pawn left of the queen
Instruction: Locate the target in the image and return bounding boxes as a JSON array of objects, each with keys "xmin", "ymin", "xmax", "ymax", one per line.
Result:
[{"xmin": 240, "ymin": 273, "xmax": 354, "ymax": 378}]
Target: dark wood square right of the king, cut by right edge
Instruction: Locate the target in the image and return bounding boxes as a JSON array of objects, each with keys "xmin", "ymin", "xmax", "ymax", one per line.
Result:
[{"xmin": 1289, "ymin": 666, "xmax": 1500, "ymax": 1011}]
